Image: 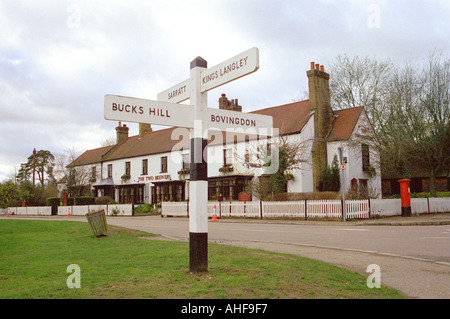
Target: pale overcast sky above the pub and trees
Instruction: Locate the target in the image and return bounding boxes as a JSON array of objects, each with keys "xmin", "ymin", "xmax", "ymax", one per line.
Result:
[{"xmin": 0, "ymin": 0, "xmax": 450, "ymax": 182}]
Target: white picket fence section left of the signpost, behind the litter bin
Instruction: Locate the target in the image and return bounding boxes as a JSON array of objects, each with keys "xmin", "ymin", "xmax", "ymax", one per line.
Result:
[{"xmin": 0, "ymin": 204, "xmax": 133, "ymax": 216}]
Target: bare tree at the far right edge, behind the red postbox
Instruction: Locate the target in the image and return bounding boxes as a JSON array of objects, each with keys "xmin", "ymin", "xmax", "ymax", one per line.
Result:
[{"xmin": 402, "ymin": 52, "xmax": 450, "ymax": 196}]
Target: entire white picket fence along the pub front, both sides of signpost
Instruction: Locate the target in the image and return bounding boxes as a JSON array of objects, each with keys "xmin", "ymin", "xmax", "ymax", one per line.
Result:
[{"xmin": 0, "ymin": 197, "xmax": 450, "ymax": 219}]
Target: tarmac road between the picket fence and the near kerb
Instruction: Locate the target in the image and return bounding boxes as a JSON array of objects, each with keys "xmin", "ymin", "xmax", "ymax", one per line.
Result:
[{"xmin": 108, "ymin": 217, "xmax": 450, "ymax": 265}]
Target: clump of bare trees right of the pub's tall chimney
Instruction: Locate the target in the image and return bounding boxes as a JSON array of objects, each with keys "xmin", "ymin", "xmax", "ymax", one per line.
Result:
[{"xmin": 330, "ymin": 51, "xmax": 450, "ymax": 196}]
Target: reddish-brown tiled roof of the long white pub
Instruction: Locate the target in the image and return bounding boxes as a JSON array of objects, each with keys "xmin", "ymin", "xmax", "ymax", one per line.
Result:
[{"xmin": 70, "ymin": 100, "xmax": 362, "ymax": 166}]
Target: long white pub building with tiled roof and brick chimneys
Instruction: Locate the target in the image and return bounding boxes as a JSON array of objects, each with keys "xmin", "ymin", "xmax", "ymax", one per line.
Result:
[{"xmin": 68, "ymin": 63, "xmax": 381, "ymax": 204}]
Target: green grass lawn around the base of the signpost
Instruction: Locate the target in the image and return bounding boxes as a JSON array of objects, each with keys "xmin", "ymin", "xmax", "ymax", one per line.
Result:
[{"xmin": 0, "ymin": 219, "xmax": 403, "ymax": 299}]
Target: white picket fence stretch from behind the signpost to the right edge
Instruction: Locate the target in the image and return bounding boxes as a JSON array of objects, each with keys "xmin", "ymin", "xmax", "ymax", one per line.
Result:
[{"xmin": 161, "ymin": 197, "xmax": 450, "ymax": 219}]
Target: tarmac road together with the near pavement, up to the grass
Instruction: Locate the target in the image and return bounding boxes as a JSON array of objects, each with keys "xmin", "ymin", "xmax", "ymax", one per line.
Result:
[{"xmin": 103, "ymin": 217, "xmax": 450, "ymax": 299}]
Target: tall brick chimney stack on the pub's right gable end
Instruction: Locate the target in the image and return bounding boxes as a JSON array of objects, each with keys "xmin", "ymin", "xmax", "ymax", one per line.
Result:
[{"xmin": 306, "ymin": 62, "xmax": 334, "ymax": 190}]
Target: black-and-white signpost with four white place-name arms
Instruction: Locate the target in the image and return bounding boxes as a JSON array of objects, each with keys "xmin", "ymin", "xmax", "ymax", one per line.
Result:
[{"xmin": 104, "ymin": 48, "xmax": 273, "ymax": 273}]
